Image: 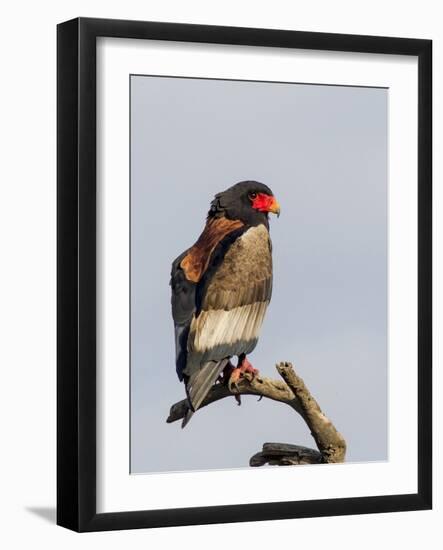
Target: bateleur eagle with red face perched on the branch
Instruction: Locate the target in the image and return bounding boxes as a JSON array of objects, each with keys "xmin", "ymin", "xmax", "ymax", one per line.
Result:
[{"xmin": 171, "ymin": 181, "xmax": 280, "ymax": 427}]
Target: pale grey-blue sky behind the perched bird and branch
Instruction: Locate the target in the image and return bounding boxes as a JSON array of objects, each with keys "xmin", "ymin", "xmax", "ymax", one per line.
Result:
[{"xmin": 131, "ymin": 76, "xmax": 388, "ymax": 473}]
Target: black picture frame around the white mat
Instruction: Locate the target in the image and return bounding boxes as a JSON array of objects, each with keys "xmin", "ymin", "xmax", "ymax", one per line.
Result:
[{"xmin": 57, "ymin": 18, "xmax": 432, "ymax": 531}]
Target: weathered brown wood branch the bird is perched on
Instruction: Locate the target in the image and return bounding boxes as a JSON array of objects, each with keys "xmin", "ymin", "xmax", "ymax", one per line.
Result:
[{"xmin": 166, "ymin": 363, "xmax": 346, "ymax": 466}]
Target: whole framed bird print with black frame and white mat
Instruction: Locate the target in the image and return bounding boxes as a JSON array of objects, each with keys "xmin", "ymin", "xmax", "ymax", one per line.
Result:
[{"xmin": 57, "ymin": 18, "xmax": 432, "ymax": 531}]
